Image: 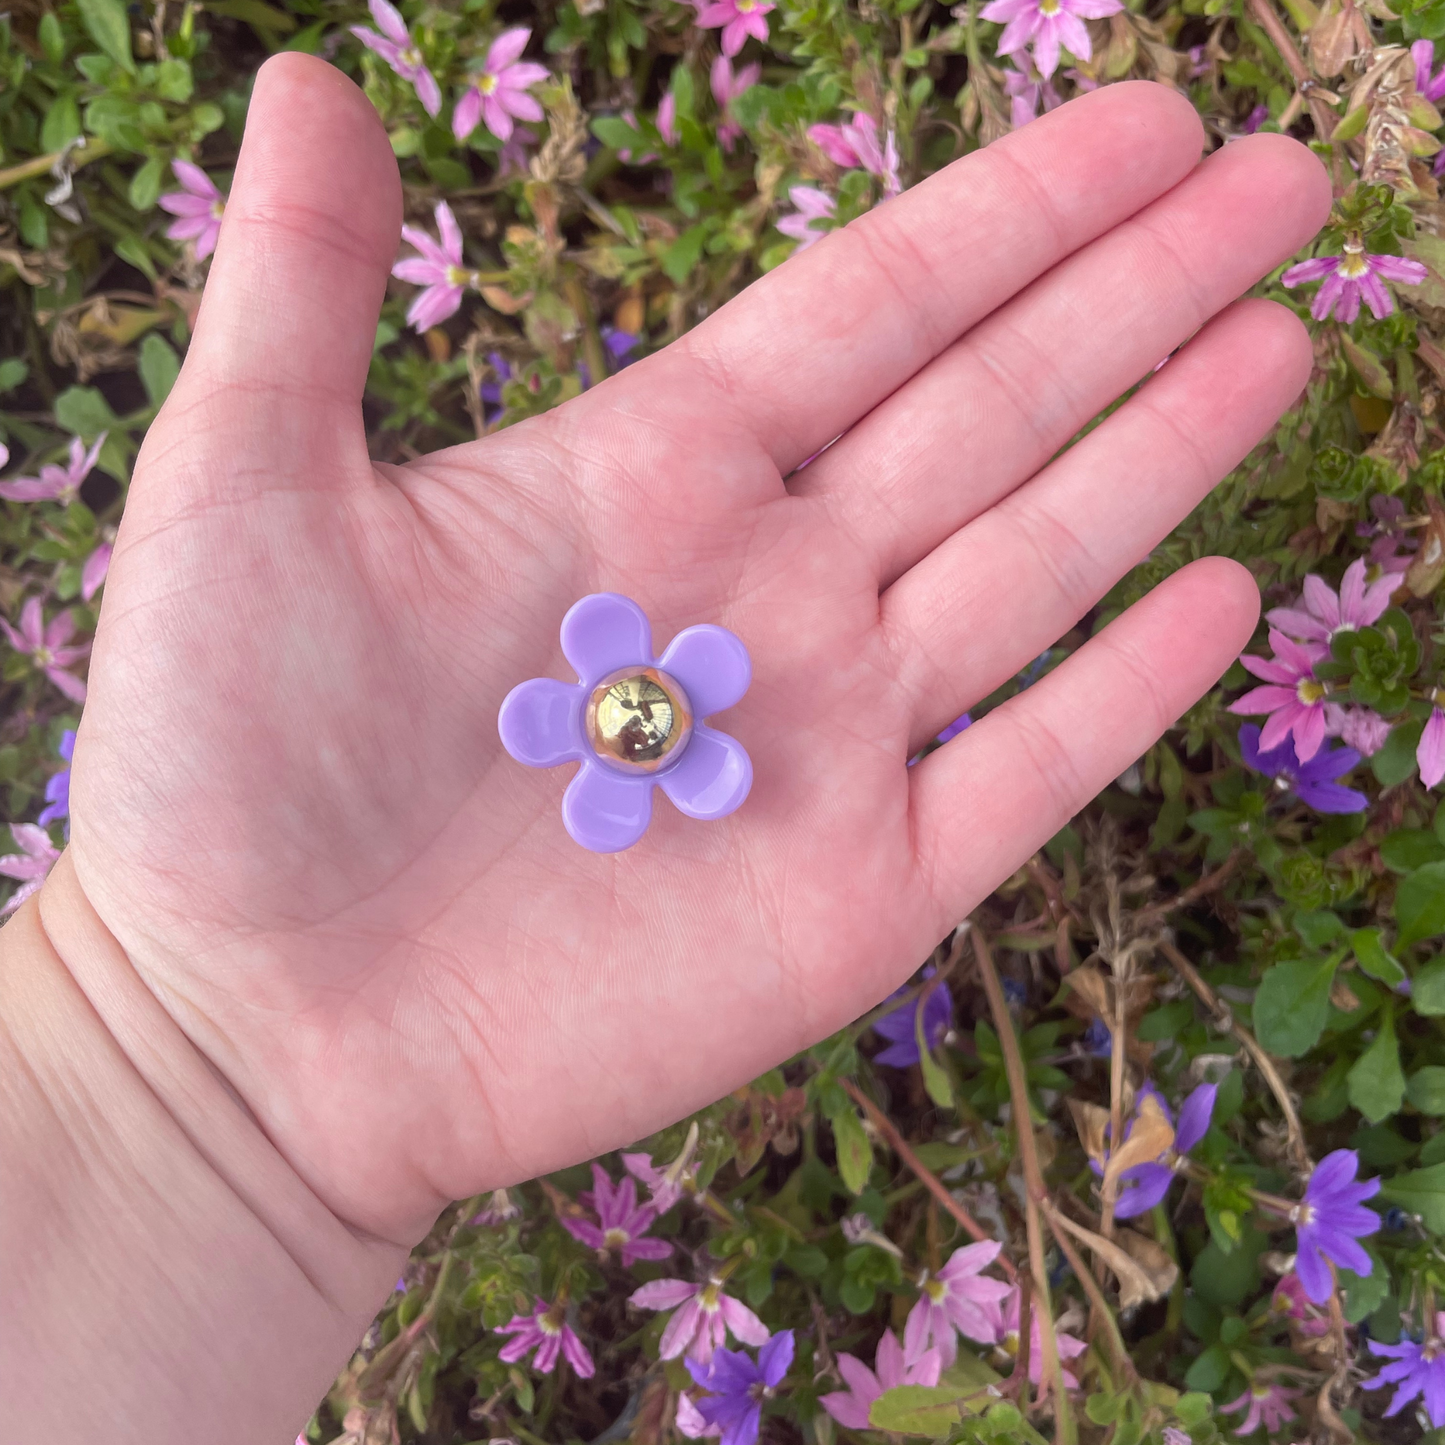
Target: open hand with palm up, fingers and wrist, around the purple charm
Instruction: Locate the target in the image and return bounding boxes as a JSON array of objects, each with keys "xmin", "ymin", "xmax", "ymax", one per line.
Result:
[{"xmin": 0, "ymin": 55, "xmax": 1329, "ymax": 1445}]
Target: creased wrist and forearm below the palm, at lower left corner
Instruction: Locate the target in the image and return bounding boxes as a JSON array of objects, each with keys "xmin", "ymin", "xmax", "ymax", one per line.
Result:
[{"xmin": 0, "ymin": 855, "xmax": 405, "ymax": 1445}]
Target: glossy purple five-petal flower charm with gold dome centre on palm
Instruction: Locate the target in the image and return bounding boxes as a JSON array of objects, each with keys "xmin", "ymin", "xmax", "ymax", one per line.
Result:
[{"xmin": 497, "ymin": 592, "xmax": 753, "ymax": 853}]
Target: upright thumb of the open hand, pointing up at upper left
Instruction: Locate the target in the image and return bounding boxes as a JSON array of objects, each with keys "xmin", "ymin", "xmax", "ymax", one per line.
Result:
[{"xmin": 168, "ymin": 53, "xmax": 402, "ymax": 480}]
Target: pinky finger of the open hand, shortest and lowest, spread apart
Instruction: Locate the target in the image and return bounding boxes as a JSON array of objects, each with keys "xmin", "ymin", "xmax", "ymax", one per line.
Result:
[{"xmin": 910, "ymin": 558, "xmax": 1259, "ymax": 926}]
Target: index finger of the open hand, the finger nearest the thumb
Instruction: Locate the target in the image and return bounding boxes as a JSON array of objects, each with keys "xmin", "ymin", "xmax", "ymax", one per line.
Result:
[{"xmin": 661, "ymin": 81, "xmax": 1204, "ymax": 474}]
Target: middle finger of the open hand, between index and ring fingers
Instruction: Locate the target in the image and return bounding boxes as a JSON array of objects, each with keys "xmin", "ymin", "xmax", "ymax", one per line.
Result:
[{"xmin": 790, "ymin": 136, "xmax": 1329, "ymax": 590}]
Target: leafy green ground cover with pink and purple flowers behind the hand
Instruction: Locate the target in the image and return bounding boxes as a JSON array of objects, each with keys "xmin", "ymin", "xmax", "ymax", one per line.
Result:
[{"xmin": 8, "ymin": 0, "xmax": 1445, "ymax": 1445}]
